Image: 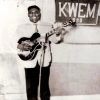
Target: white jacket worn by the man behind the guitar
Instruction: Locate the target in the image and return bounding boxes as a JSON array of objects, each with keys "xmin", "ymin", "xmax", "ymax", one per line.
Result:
[{"xmin": 16, "ymin": 22, "xmax": 52, "ymax": 68}]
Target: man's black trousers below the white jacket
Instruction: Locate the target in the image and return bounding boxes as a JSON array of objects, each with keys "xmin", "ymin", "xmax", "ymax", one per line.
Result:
[{"xmin": 25, "ymin": 63, "xmax": 50, "ymax": 100}]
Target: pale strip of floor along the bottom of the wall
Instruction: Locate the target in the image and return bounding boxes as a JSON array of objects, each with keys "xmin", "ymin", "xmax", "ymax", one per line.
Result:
[{"xmin": 0, "ymin": 94, "xmax": 100, "ymax": 100}]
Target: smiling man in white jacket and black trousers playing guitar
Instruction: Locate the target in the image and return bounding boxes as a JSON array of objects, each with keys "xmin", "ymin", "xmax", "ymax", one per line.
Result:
[{"xmin": 17, "ymin": 5, "xmax": 65, "ymax": 100}]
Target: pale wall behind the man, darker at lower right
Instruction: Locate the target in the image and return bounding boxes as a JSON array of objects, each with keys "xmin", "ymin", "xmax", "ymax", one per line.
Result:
[{"xmin": 0, "ymin": 0, "xmax": 100, "ymax": 99}]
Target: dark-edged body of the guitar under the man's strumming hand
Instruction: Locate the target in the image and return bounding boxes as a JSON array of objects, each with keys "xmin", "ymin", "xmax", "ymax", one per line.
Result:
[{"xmin": 18, "ymin": 33, "xmax": 41, "ymax": 61}]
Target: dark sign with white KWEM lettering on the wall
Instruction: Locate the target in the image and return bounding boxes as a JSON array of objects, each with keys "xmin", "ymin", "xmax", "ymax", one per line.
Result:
[{"xmin": 55, "ymin": 0, "xmax": 100, "ymax": 25}]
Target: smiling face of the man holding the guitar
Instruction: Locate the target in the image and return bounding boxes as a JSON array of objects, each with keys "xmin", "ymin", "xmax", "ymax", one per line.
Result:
[{"xmin": 28, "ymin": 8, "xmax": 41, "ymax": 23}]
